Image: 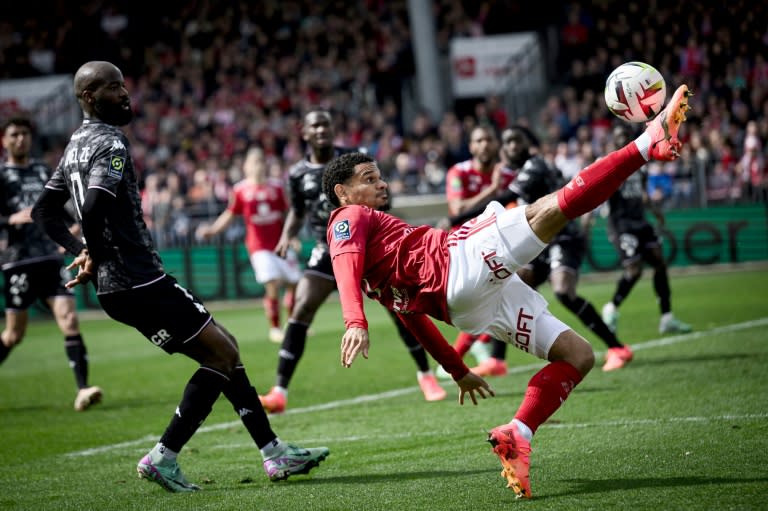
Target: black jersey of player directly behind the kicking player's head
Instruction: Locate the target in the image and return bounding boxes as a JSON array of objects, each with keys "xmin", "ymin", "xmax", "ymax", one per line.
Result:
[{"xmin": 288, "ymin": 147, "xmax": 353, "ymax": 244}]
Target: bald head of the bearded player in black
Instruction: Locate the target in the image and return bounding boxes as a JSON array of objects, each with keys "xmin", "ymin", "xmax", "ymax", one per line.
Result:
[{"xmin": 74, "ymin": 60, "xmax": 133, "ymax": 126}]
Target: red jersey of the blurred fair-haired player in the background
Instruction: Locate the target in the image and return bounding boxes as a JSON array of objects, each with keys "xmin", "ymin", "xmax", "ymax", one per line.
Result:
[{"xmin": 229, "ymin": 180, "xmax": 288, "ymax": 254}]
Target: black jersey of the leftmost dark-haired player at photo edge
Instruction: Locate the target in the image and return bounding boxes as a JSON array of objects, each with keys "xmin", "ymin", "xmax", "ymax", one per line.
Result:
[{"xmin": 0, "ymin": 161, "xmax": 64, "ymax": 269}]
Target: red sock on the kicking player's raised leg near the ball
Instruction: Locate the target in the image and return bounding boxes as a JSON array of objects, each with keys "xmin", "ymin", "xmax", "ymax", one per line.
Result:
[{"xmin": 557, "ymin": 141, "xmax": 647, "ymax": 219}]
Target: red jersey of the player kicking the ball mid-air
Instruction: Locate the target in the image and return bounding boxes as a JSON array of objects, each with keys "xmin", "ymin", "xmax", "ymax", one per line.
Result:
[{"xmin": 328, "ymin": 206, "xmax": 450, "ymax": 325}]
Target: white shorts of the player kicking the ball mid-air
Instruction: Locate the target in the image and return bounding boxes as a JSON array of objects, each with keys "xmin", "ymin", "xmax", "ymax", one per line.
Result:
[{"xmin": 447, "ymin": 202, "xmax": 570, "ymax": 360}]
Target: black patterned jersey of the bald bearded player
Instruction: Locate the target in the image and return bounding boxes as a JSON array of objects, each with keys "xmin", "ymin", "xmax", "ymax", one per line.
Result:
[{"xmin": 46, "ymin": 119, "xmax": 163, "ymax": 294}]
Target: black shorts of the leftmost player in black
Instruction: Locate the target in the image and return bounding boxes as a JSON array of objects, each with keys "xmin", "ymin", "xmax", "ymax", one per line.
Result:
[{"xmin": 3, "ymin": 259, "xmax": 74, "ymax": 310}]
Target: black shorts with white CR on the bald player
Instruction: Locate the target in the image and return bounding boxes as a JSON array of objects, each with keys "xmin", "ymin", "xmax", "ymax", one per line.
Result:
[{"xmin": 98, "ymin": 275, "xmax": 211, "ymax": 353}]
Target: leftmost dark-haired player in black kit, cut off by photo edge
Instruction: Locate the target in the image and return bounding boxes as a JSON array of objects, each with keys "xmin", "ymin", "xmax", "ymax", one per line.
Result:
[{"xmin": 0, "ymin": 117, "xmax": 102, "ymax": 412}]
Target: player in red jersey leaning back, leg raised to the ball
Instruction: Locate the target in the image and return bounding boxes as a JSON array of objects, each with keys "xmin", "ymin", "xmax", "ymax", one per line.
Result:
[{"xmin": 323, "ymin": 85, "xmax": 690, "ymax": 498}]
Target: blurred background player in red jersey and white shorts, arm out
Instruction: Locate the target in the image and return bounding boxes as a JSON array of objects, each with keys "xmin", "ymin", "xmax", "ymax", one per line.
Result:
[{"xmin": 197, "ymin": 147, "xmax": 301, "ymax": 342}]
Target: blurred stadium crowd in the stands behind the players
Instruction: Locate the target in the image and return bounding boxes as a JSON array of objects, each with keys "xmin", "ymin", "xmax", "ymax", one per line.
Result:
[{"xmin": 0, "ymin": 0, "xmax": 768, "ymax": 247}]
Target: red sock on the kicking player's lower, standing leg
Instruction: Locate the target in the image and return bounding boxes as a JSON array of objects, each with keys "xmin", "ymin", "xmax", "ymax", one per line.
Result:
[{"xmin": 515, "ymin": 360, "xmax": 582, "ymax": 433}]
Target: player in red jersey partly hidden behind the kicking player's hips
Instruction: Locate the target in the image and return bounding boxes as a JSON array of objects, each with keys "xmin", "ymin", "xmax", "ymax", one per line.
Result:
[{"xmin": 438, "ymin": 125, "xmax": 516, "ymax": 374}]
